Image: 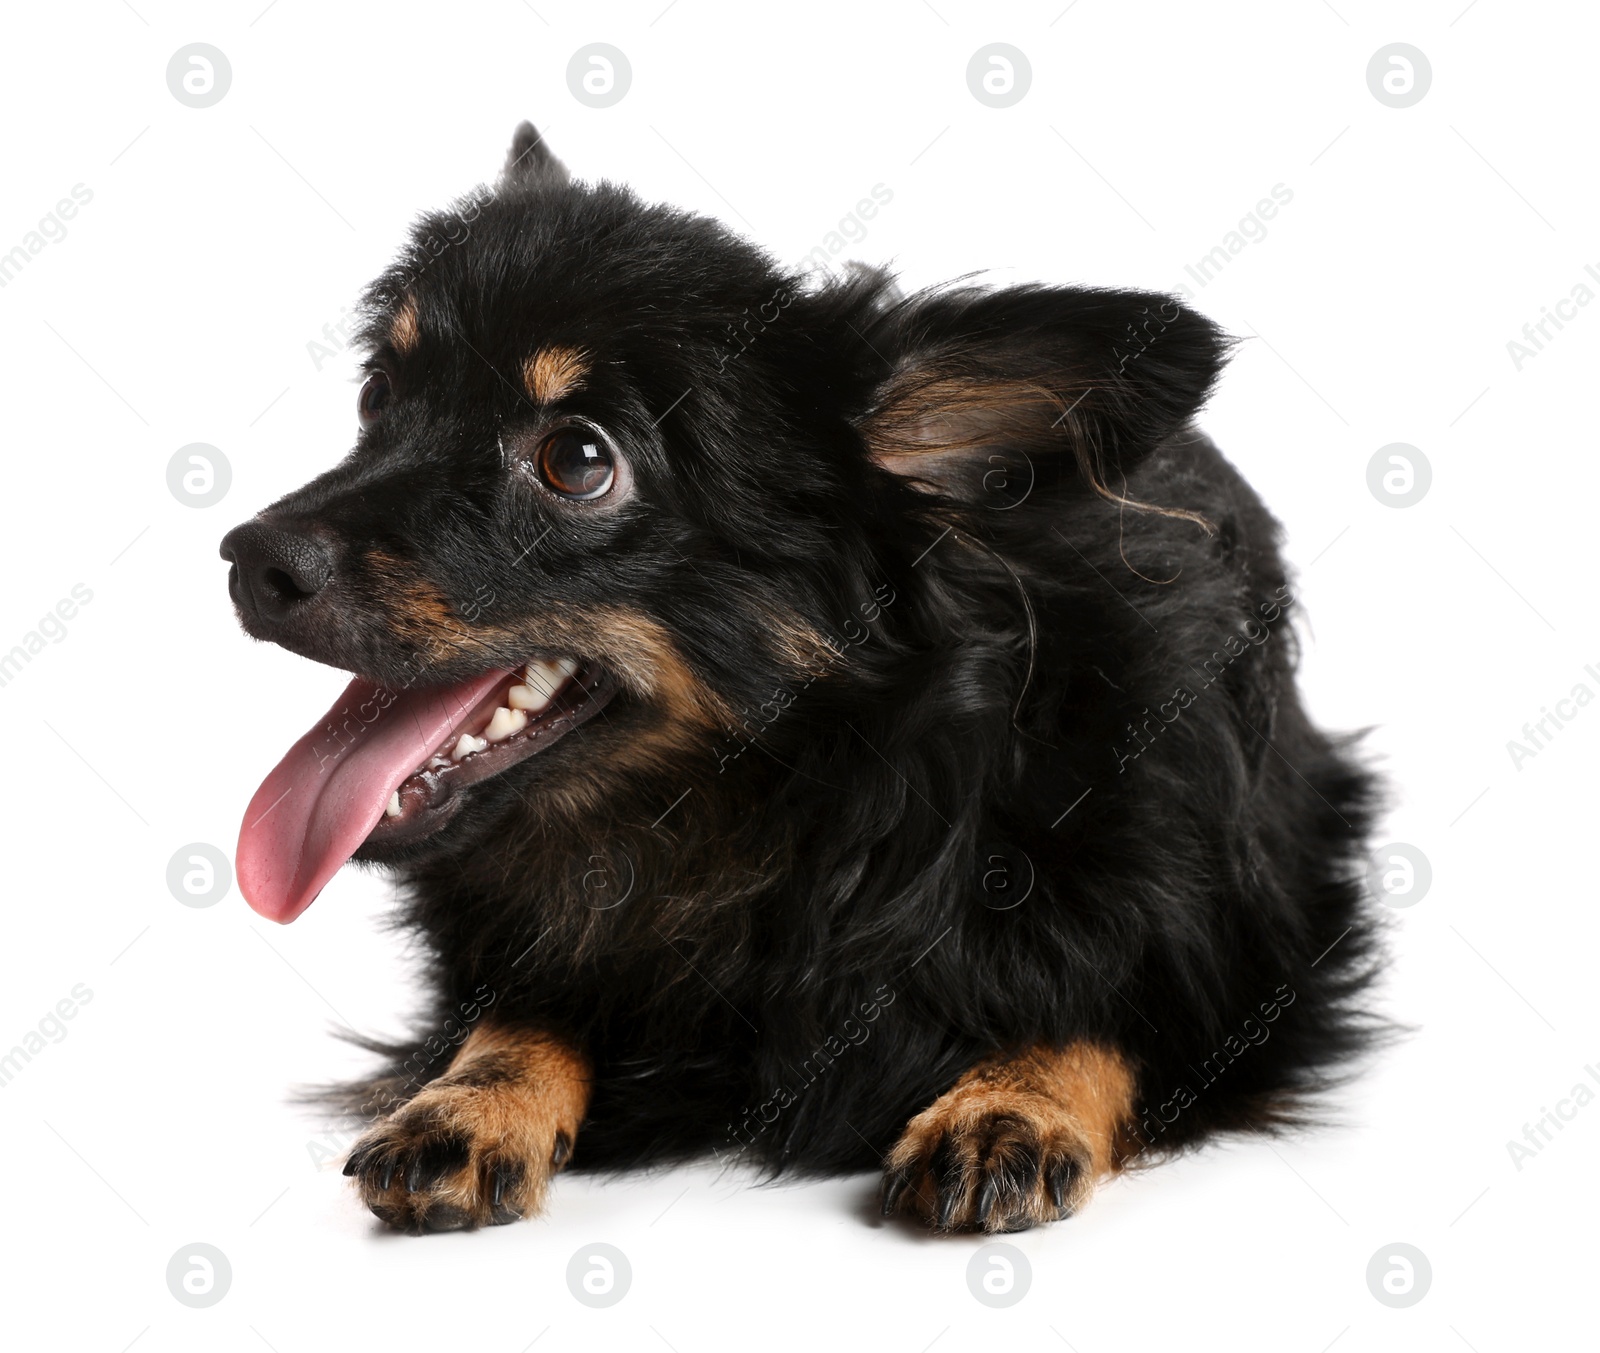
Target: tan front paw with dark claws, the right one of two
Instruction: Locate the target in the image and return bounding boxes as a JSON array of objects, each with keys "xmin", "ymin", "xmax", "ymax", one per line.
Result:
[{"xmin": 883, "ymin": 1043, "xmax": 1134, "ymax": 1231}]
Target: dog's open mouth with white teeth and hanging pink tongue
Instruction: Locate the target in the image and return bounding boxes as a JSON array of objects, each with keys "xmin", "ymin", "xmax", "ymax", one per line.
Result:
[{"xmin": 237, "ymin": 656, "xmax": 616, "ymax": 921}]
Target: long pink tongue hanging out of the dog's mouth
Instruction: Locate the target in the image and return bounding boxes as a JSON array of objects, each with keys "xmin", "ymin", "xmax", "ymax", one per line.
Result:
[{"xmin": 237, "ymin": 670, "xmax": 509, "ymax": 924}]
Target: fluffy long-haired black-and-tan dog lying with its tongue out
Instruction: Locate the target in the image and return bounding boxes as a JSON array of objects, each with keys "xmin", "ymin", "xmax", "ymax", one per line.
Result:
[{"xmin": 222, "ymin": 125, "xmax": 1379, "ymax": 1231}]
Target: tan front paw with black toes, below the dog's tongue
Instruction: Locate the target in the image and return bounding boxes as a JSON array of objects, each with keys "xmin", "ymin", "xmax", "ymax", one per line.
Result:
[{"xmin": 344, "ymin": 1027, "xmax": 590, "ymax": 1235}]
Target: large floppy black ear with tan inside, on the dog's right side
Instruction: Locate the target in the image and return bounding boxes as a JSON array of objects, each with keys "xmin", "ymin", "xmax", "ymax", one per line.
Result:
[{"xmin": 859, "ymin": 286, "xmax": 1229, "ymax": 514}]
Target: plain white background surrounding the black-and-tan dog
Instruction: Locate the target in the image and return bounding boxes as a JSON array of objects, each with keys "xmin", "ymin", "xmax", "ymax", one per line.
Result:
[{"xmin": 0, "ymin": 0, "xmax": 1600, "ymax": 1353}]
